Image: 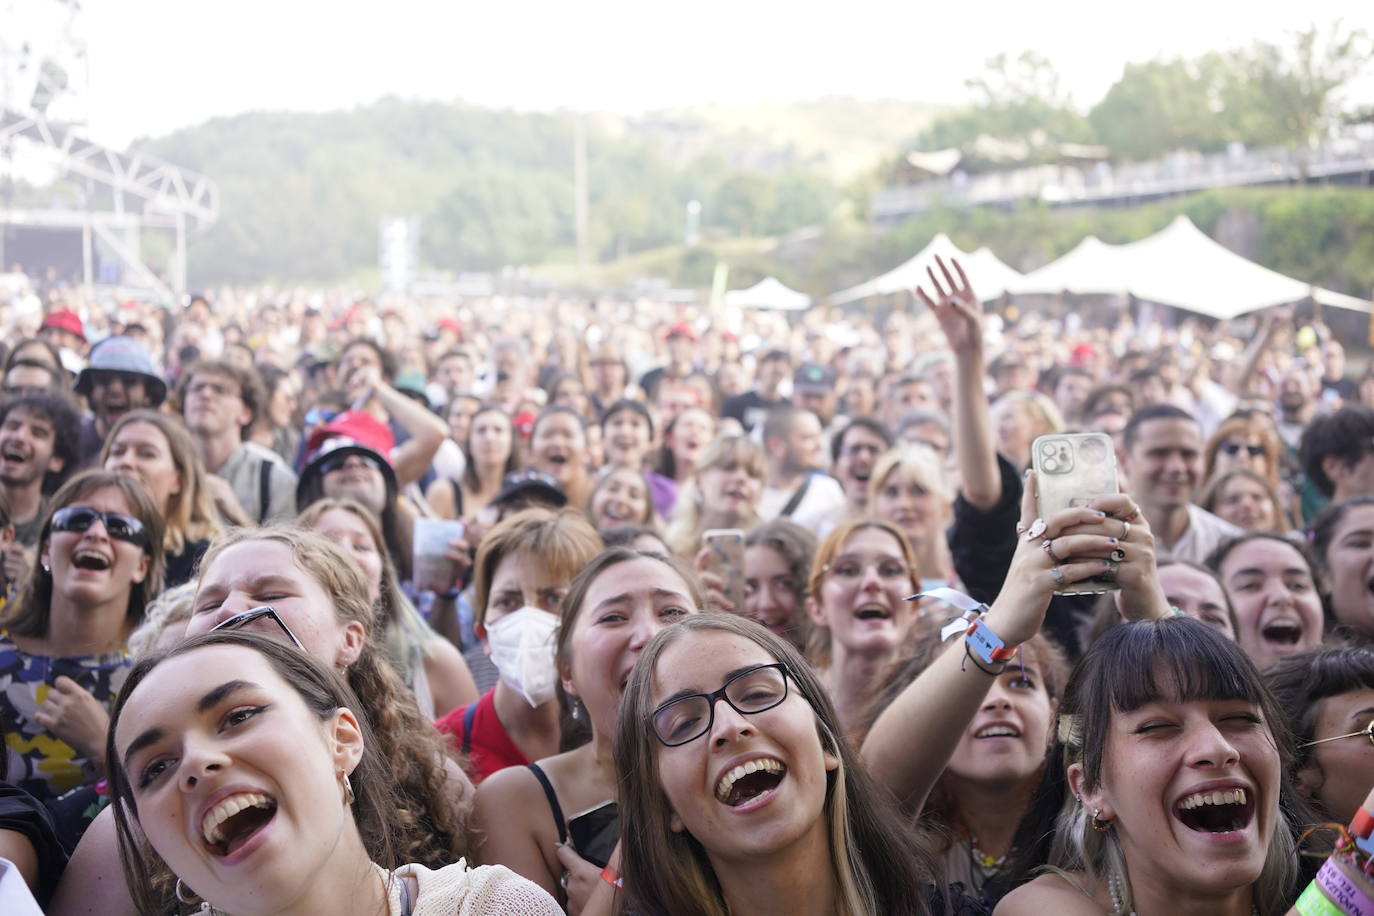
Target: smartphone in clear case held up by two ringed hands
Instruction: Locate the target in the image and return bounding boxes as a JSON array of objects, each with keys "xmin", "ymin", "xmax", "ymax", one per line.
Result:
[{"xmin": 1031, "ymin": 433, "xmax": 1121, "ymax": 595}]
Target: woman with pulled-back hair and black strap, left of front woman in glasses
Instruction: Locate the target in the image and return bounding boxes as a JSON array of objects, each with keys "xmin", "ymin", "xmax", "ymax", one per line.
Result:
[{"xmin": 477, "ymin": 547, "xmax": 703, "ymax": 912}]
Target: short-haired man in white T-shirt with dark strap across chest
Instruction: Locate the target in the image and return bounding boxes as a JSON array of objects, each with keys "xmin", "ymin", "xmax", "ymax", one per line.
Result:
[{"xmin": 758, "ymin": 405, "xmax": 845, "ymax": 531}]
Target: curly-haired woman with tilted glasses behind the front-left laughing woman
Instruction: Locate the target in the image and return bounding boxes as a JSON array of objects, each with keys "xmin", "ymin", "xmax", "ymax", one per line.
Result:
[{"xmin": 49, "ymin": 526, "xmax": 473, "ymax": 916}]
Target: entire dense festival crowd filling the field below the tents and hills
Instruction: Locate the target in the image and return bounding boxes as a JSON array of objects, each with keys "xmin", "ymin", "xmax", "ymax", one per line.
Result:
[{"xmin": 0, "ymin": 262, "xmax": 1374, "ymax": 916}]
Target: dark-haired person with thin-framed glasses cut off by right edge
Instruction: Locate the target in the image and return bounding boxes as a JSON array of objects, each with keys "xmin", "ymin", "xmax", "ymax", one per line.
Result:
[{"xmin": 1264, "ymin": 645, "xmax": 1374, "ymax": 824}]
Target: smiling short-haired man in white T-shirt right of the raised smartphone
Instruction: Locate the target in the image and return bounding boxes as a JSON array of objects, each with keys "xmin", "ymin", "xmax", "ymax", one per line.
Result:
[{"xmin": 1121, "ymin": 404, "xmax": 1243, "ymax": 563}]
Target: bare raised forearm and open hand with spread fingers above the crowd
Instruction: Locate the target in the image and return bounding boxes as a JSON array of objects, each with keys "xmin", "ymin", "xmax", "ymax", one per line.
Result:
[{"xmin": 916, "ymin": 257, "xmax": 1002, "ymax": 511}]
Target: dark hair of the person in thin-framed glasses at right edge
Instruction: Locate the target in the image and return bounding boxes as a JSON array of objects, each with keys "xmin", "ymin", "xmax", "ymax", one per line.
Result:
[{"xmin": 1264, "ymin": 645, "xmax": 1374, "ymax": 791}]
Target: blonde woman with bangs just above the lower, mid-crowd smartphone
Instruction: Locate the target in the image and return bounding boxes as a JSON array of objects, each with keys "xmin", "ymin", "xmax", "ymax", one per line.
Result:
[{"xmin": 664, "ymin": 435, "xmax": 768, "ymax": 559}]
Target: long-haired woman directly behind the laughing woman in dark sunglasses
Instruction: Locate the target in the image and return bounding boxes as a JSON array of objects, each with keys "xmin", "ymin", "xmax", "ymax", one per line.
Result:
[{"xmin": 99, "ymin": 411, "xmax": 224, "ymax": 588}]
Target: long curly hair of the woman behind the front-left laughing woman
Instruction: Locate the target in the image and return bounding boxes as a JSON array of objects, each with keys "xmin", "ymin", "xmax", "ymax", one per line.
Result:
[{"xmin": 196, "ymin": 526, "xmax": 471, "ymax": 868}]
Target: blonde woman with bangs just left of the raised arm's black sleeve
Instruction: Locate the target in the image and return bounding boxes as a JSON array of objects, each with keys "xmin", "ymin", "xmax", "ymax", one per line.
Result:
[{"xmin": 868, "ymin": 445, "xmax": 958, "ymax": 589}]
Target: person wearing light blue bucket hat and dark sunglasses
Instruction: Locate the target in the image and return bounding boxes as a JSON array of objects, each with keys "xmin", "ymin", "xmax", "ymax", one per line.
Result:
[{"xmin": 76, "ymin": 336, "xmax": 168, "ymax": 467}]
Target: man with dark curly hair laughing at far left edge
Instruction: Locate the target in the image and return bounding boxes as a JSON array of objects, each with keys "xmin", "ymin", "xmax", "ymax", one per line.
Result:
[{"xmin": 0, "ymin": 394, "xmax": 80, "ymax": 584}]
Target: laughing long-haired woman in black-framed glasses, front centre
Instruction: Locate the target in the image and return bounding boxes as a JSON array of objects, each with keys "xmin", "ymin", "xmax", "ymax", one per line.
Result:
[{"xmin": 615, "ymin": 614, "xmax": 945, "ymax": 916}]
